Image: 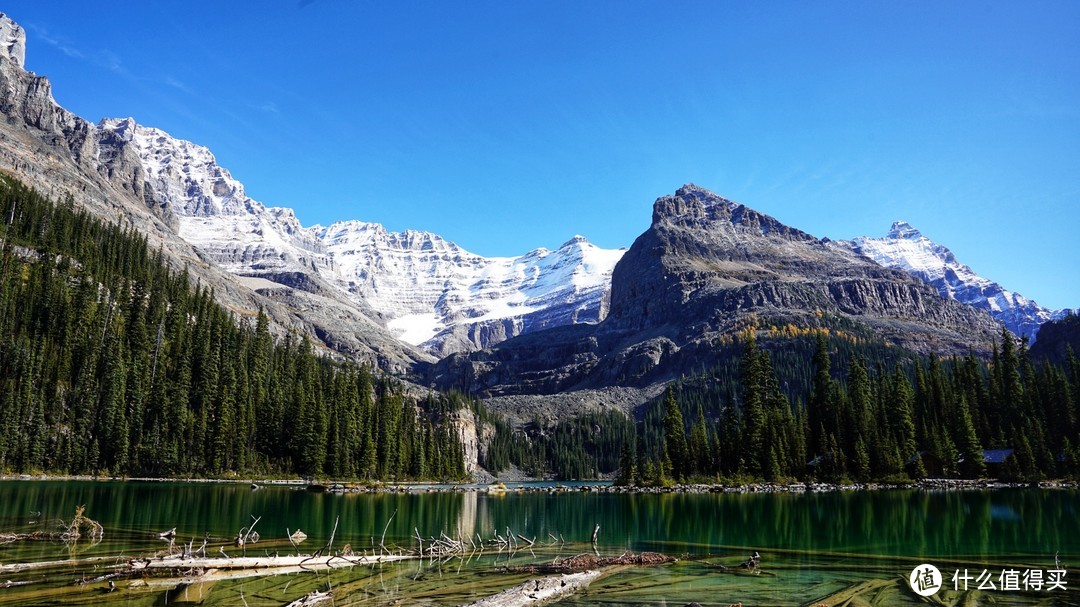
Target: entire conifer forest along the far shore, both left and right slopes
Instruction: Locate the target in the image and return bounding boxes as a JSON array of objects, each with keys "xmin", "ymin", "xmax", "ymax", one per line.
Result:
[{"xmin": 0, "ymin": 177, "xmax": 1080, "ymax": 485}]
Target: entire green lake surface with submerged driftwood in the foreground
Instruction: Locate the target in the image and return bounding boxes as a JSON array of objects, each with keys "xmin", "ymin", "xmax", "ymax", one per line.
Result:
[{"xmin": 0, "ymin": 481, "xmax": 1080, "ymax": 607}]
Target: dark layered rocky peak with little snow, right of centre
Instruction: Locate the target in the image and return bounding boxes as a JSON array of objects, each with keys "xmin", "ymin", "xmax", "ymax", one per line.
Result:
[{"xmin": 610, "ymin": 186, "xmax": 993, "ymax": 350}]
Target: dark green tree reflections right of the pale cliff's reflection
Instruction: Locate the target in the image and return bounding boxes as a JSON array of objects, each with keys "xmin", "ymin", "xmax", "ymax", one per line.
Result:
[{"xmin": 457, "ymin": 489, "xmax": 1080, "ymax": 557}]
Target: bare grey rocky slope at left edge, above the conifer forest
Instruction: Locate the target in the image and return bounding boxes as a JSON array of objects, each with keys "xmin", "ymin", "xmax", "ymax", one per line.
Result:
[{"xmin": 0, "ymin": 14, "xmax": 431, "ymax": 373}]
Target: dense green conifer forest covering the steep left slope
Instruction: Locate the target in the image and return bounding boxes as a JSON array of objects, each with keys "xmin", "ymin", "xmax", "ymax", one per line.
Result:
[{"xmin": 0, "ymin": 177, "xmax": 468, "ymax": 480}]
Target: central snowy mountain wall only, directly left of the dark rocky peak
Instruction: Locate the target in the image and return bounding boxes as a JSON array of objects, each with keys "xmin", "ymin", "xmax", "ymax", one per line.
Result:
[{"xmin": 316, "ymin": 221, "xmax": 623, "ymax": 355}]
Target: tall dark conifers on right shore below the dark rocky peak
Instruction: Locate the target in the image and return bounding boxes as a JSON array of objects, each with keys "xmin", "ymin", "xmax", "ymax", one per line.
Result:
[{"xmin": 619, "ymin": 327, "xmax": 1080, "ymax": 484}]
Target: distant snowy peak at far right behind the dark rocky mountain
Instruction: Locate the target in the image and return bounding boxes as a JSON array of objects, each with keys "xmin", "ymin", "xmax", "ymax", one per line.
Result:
[{"xmin": 842, "ymin": 221, "xmax": 1068, "ymax": 339}]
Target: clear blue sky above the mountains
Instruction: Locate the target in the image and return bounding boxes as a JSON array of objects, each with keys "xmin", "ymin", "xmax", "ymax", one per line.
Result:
[{"xmin": 8, "ymin": 0, "xmax": 1080, "ymax": 308}]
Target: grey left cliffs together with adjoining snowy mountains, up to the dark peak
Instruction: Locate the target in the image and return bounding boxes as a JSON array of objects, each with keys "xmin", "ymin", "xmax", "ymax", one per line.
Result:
[{"xmin": 0, "ymin": 12, "xmax": 622, "ymax": 362}]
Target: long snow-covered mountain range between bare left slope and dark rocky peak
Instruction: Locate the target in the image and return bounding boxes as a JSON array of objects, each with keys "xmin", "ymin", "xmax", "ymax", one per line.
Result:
[{"xmin": 98, "ymin": 118, "xmax": 623, "ymax": 355}]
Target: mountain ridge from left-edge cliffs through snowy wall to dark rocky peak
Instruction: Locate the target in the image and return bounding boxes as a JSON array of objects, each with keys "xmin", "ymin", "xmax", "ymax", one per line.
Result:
[{"xmin": 0, "ymin": 9, "xmax": 1062, "ymax": 402}]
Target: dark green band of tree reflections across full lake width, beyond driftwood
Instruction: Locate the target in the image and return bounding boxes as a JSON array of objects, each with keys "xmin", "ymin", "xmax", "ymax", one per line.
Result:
[{"xmin": 0, "ymin": 482, "xmax": 1080, "ymax": 564}]
